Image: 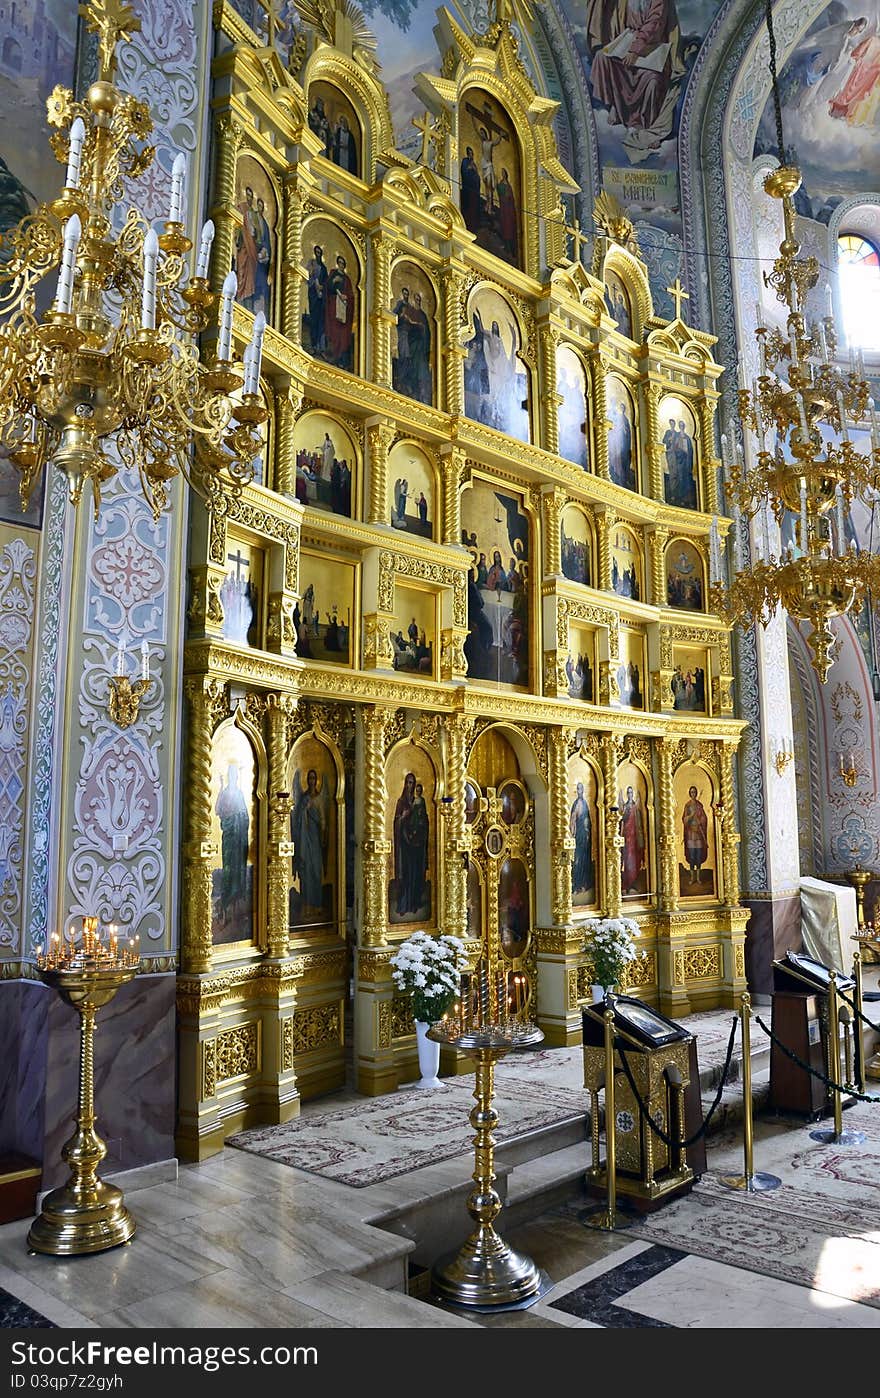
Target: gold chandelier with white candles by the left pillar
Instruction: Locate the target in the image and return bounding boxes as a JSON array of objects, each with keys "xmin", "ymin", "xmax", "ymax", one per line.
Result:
[{"xmin": 0, "ymin": 0, "xmax": 267, "ymax": 519}]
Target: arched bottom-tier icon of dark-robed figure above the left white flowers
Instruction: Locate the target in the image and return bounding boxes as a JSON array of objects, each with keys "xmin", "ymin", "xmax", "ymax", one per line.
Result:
[{"xmin": 385, "ymin": 742, "xmax": 437, "ymax": 927}]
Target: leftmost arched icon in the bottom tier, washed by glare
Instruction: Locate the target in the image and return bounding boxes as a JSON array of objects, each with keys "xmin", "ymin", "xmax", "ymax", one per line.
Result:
[{"xmin": 211, "ymin": 721, "xmax": 257, "ymax": 946}]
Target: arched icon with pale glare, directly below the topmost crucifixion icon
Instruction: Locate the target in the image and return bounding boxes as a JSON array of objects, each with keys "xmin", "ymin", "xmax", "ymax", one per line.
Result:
[{"xmin": 464, "ymin": 282, "xmax": 532, "ymax": 442}]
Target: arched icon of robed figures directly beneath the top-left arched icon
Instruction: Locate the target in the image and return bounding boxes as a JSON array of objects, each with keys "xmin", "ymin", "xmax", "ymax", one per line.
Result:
[{"xmin": 302, "ymin": 218, "xmax": 361, "ymax": 373}]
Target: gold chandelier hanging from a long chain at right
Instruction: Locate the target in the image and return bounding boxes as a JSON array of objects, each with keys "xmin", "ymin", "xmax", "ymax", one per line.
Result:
[{"xmin": 709, "ymin": 0, "xmax": 880, "ymax": 684}]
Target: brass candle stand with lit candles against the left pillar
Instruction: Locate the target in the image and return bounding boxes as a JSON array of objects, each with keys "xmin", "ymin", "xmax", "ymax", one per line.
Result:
[{"xmin": 28, "ymin": 917, "xmax": 140, "ymax": 1257}]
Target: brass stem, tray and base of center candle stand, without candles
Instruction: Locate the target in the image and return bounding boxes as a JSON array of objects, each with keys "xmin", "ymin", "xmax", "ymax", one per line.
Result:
[{"xmin": 428, "ymin": 1023, "xmax": 550, "ymax": 1311}]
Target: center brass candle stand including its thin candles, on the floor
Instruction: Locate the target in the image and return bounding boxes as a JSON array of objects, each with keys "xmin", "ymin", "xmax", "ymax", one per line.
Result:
[{"xmin": 428, "ymin": 960, "xmax": 550, "ymax": 1313}]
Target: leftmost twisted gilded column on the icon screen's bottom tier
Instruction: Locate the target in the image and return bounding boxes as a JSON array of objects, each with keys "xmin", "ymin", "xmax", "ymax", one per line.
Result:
[{"xmin": 180, "ymin": 678, "xmax": 221, "ymax": 974}]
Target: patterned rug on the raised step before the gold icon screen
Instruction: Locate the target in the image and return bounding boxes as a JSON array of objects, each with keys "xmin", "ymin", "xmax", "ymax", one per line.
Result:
[{"xmin": 227, "ymin": 1078, "xmax": 589, "ymax": 1188}]
